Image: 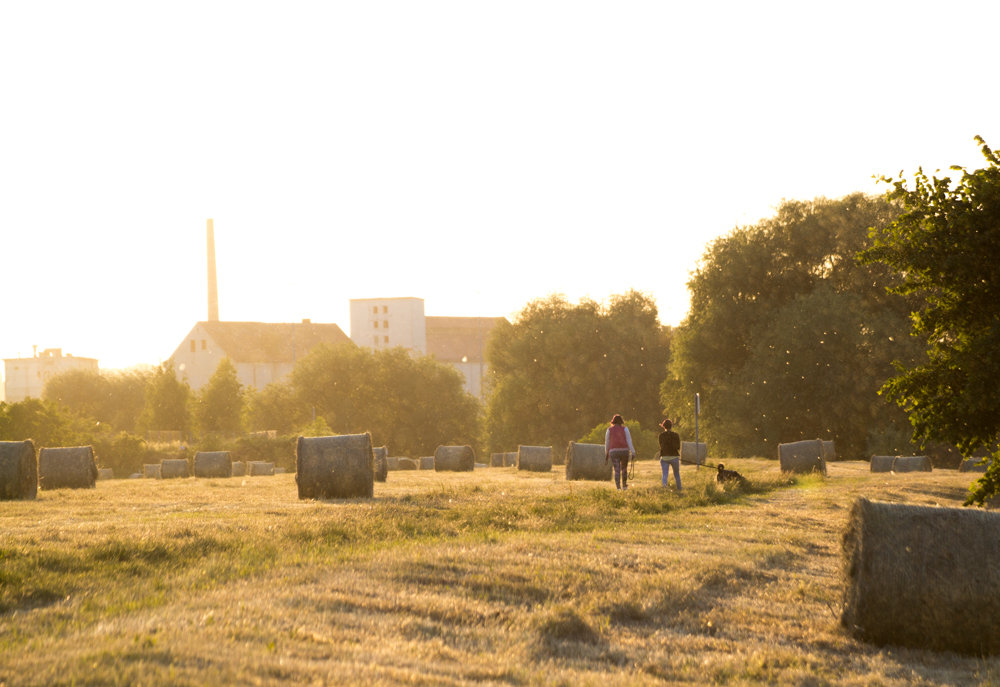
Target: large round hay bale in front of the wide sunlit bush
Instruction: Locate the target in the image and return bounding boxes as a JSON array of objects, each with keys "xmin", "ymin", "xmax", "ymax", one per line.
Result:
[{"xmin": 295, "ymin": 433, "xmax": 375, "ymax": 499}]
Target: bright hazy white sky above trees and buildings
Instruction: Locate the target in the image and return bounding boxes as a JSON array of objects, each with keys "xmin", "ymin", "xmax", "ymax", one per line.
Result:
[{"xmin": 0, "ymin": 0, "xmax": 1000, "ymax": 382}]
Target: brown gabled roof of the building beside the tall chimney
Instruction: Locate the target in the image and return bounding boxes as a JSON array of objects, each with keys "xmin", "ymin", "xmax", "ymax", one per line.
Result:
[{"xmin": 198, "ymin": 322, "xmax": 351, "ymax": 363}]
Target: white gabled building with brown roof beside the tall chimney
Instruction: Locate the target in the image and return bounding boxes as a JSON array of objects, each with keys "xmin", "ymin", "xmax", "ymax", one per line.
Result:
[{"xmin": 170, "ymin": 320, "xmax": 350, "ymax": 390}]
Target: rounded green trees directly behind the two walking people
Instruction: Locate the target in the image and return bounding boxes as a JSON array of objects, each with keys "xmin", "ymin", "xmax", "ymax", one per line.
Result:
[{"xmin": 486, "ymin": 291, "xmax": 670, "ymax": 452}]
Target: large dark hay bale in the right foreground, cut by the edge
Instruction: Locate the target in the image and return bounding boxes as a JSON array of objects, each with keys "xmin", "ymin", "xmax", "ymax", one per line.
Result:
[{"xmin": 841, "ymin": 498, "xmax": 1000, "ymax": 655}]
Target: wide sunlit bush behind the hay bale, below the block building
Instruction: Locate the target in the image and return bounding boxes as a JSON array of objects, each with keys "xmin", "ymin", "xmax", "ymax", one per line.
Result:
[{"xmin": 291, "ymin": 343, "xmax": 479, "ymax": 456}]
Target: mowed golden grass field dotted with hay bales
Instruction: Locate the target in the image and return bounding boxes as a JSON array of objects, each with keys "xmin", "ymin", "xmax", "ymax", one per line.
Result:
[{"xmin": 0, "ymin": 460, "xmax": 1000, "ymax": 687}]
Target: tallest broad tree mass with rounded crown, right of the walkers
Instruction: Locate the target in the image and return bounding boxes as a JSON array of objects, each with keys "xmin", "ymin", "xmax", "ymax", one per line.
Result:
[{"xmin": 661, "ymin": 194, "xmax": 923, "ymax": 458}]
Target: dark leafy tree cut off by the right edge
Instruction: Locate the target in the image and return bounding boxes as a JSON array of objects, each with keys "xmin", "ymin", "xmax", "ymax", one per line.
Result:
[{"xmin": 862, "ymin": 136, "xmax": 1000, "ymax": 503}]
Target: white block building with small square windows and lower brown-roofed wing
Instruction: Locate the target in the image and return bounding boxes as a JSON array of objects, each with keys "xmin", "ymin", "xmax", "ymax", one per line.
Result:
[{"xmin": 351, "ymin": 298, "xmax": 502, "ymax": 398}]
